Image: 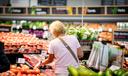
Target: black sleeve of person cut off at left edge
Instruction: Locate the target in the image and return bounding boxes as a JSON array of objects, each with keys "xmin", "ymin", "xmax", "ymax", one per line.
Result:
[{"xmin": 0, "ymin": 42, "xmax": 10, "ymax": 73}]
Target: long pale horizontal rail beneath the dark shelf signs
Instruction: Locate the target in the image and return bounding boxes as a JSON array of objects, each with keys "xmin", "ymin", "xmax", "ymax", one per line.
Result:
[{"xmin": 0, "ymin": 15, "xmax": 128, "ymax": 22}]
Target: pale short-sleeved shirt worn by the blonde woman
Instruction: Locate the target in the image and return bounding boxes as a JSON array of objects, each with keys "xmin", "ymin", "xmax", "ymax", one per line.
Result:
[{"xmin": 48, "ymin": 35, "xmax": 80, "ymax": 73}]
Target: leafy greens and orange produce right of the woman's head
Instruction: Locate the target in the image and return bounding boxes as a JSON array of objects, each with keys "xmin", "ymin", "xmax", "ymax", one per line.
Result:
[{"xmin": 66, "ymin": 23, "xmax": 117, "ymax": 41}]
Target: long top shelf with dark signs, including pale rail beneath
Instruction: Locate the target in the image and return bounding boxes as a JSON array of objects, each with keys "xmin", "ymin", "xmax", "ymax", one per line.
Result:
[{"xmin": 0, "ymin": 5, "xmax": 128, "ymax": 22}]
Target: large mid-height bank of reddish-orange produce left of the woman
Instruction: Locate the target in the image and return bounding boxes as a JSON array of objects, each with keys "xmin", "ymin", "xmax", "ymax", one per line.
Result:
[{"xmin": 0, "ymin": 32, "xmax": 48, "ymax": 53}]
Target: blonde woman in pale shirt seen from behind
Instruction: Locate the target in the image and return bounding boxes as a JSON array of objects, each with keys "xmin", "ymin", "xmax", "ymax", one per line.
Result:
[{"xmin": 42, "ymin": 21, "xmax": 83, "ymax": 76}]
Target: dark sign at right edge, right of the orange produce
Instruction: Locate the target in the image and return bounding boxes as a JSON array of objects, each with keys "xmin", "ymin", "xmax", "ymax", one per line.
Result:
[{"xmin": 114, "ymin": 31, "xmax": 128, "ymax": 41}]
